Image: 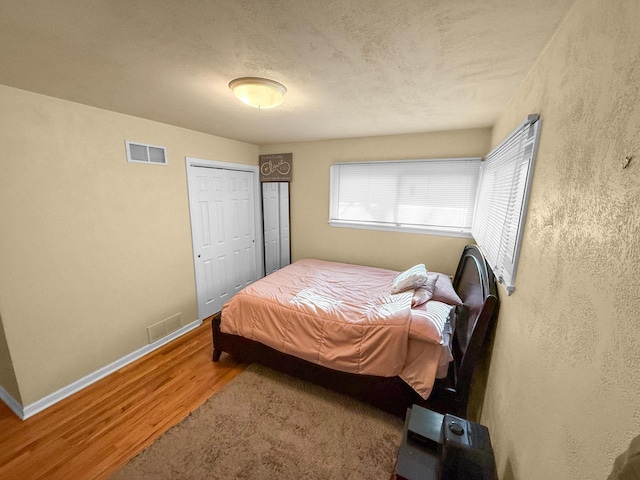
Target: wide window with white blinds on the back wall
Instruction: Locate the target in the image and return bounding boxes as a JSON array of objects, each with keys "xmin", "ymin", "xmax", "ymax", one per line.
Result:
[{"xmin": 329, "ymin": 158, "xmax": 480, "ymax": 237}]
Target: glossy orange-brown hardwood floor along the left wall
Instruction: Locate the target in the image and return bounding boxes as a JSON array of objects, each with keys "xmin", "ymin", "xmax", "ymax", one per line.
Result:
[{"xmin": 0, "ymin": 320, "xmax": 245, "ymax": 480}]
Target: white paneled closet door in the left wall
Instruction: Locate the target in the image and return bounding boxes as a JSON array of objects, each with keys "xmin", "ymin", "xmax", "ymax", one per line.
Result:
[{"xmin": 191, "ymin": 167, "xmax": 258, "ymax": 318}]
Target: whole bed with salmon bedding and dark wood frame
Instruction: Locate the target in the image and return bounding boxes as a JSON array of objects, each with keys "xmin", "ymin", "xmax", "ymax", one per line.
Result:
[{"xmin": 212, "ymin": 245, "xmax": 498, "ymax": 418}]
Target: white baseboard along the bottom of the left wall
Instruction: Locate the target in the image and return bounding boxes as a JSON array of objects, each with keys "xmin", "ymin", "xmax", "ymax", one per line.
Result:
[{"xmin": 0, "ymin": 320, "xmax": 202, "ymax": 420}]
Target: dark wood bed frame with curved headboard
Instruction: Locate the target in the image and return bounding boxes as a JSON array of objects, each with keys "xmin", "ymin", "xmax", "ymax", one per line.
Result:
[{"xmin": 212, "ymin": 245, "xmax": 498, "ymax": 418}]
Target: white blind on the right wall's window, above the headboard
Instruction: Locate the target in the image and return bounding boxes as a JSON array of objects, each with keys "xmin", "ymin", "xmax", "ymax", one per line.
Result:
[{"xmin": 472, "ymin": 115, "xmax": 542, "ymax": 295}]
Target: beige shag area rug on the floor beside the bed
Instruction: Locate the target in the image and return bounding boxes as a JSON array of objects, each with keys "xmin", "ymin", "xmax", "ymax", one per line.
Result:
[{"xmin": 112, "ymin": 364, "xmax": 402, "ymax": 480}]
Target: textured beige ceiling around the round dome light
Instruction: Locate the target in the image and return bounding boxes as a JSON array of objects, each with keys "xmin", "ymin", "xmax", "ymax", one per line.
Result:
[{"xmin": 0, "ymin": 0, "xmax": 575, "ymax": 144}]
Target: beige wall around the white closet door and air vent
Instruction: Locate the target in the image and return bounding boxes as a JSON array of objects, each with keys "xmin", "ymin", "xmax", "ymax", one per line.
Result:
[{"xmin": 0, "ymin": 86, "xmax": 258, "ymax": 405}]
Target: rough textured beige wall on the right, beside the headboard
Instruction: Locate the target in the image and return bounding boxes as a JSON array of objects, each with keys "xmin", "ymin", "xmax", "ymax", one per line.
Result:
[{"xmin": 483, "ymin": 0, "xmax": 640, "ymax": 480}]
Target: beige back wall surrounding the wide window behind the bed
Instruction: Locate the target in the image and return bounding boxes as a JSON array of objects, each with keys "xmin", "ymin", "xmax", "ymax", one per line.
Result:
[{"xmin": 260, "ymin": 129, "xmax": 490, "ymax": 274}]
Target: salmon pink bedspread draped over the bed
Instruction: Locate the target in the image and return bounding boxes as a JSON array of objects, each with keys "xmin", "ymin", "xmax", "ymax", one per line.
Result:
[{"xmin": 220, "ymin": 259, "xmax": 442, "ymax": 398}]
